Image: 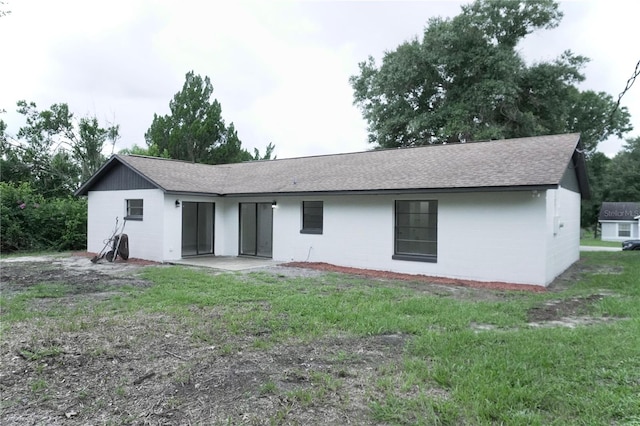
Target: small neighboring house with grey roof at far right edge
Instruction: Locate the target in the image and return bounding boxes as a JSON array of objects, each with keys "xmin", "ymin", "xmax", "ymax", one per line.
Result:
[{"xmin": 598, "ymin": 202, "xmax": 640, "ymax": 241}]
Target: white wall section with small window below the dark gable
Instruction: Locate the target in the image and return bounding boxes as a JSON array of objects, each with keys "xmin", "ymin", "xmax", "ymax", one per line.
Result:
[{"xmin": 87, "ymin": 189, "xmax": 165, "ymax": 261}]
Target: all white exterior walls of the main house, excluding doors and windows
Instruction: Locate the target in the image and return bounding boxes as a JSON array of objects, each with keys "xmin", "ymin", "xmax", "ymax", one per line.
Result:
[{"xmin": 88, "ymin": 188, "xmax": 580, "ymax": 286}]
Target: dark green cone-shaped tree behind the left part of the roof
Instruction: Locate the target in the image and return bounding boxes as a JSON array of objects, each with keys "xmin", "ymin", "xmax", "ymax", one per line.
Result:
[{"xmin": 145, "ymin": 71, "xmax": 273, "ymax": 164}]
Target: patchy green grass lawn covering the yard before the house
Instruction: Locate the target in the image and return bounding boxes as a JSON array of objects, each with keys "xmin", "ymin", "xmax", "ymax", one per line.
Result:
[{"xmin": 0, "ymin": 252, "xmax": 640, "ymax": 425}]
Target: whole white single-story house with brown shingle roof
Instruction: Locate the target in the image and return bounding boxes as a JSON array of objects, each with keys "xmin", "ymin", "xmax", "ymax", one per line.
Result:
[{"xmin": 76, "ymin": 134, "xmax": 589, "ymax": 286}]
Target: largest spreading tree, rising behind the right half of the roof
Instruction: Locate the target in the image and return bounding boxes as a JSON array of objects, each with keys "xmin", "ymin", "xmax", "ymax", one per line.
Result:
[{"xmin": 350, "ymin": 0, "xmax": 631, "ymax": 154}]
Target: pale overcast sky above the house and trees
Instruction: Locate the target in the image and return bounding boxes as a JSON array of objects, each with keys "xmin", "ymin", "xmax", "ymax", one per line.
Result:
[{"xmin": 0, "ymin": 0, "xmax": 640, "ymax": 158}]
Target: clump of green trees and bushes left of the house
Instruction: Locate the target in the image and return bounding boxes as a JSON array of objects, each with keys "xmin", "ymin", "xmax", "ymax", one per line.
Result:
[{"xmin": 0, "ymin": 101, "xmax": 118, "ymax": 252}]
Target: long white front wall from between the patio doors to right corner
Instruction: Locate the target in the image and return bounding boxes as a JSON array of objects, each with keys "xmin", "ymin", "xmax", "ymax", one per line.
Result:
[{"xmin": 218, "ymin": 191, "xmax": 547, "ymax": 285}]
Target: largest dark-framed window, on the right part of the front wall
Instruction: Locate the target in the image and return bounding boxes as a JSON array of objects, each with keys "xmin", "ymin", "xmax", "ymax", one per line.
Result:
[{"xmin": 393, "ymin": 200, "xmax": 438, "ymax": 262}]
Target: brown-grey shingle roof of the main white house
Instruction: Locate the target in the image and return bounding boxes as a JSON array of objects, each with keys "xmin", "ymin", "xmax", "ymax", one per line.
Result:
[{"xmin": 77, "ymin": 134, "xmax": 588, "ymax": 195}]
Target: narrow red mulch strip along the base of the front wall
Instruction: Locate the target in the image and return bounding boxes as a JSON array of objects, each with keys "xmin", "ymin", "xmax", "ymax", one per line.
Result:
[{"xmin": 282, "ymin": 262, "xmax": 547, "ymax": 293}]
